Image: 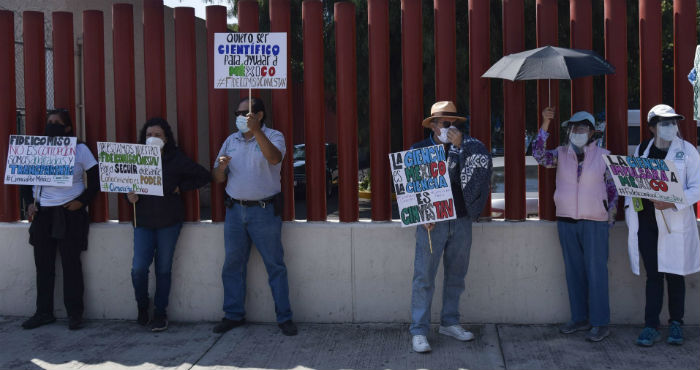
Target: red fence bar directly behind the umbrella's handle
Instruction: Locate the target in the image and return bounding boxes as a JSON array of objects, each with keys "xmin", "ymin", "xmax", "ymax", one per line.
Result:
[{"xmin": 536, "ymin": 0, "xmax": 561, "ymax": 221}]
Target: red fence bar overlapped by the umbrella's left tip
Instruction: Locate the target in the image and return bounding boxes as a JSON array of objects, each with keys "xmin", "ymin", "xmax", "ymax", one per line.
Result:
[{"xmin": 468, "ymin": 0, "xmax": 491, "ymax": 217}]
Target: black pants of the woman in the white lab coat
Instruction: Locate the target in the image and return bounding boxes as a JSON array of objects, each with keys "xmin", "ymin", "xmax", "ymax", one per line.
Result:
[{"xmin": 637, "ymin": 222, "xmax": 685, "ymax": 328}]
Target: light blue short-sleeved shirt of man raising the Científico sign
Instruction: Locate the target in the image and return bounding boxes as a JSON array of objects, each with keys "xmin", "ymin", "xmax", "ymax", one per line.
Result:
[{"xmin": 214, "ymin": 126, "xmax": 286, "ymax": 200}]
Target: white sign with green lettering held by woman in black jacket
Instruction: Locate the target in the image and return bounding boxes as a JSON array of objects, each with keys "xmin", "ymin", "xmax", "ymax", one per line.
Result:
[{"xmin": 97, "ymin": 142, "xmax": 163, "ymax": 196}]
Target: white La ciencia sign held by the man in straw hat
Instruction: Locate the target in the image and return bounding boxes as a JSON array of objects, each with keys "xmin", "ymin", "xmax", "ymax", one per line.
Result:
[{"xmin": 389, "ymin": 145, "xmax": 457, "ymax": 227}]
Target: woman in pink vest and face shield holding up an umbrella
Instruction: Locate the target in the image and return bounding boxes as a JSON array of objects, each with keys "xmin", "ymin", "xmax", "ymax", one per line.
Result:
[{"xmin": 532, "ymin": 107, "xmax": 617, "ymax": 342}]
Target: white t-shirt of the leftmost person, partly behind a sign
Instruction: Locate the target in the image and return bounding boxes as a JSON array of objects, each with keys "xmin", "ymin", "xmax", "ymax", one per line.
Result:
[{"xmin": 33, "ymin": 144, "xmax": 97, "ymax": 207}]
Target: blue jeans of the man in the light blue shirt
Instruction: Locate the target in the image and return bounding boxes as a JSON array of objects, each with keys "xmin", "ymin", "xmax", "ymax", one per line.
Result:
[{"xmin": 221, "ymin": 204, "xmax": 292, "ymax": 323}]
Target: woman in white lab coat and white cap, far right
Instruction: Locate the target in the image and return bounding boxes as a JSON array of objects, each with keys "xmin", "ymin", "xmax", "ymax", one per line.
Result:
[{"xmin": 625, "ymin": 104, "xmax": 700, "ymax": 347}]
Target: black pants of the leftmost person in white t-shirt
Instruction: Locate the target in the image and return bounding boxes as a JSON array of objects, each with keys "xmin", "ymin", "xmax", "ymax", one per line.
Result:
[{"xmin": 34, "ymin": 239, "xmax": 84, "ymax": 316}]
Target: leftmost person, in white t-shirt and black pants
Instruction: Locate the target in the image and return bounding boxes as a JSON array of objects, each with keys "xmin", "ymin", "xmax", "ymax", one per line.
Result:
[{"xmin": 22, "ymin": 109, "xmax": 100, "ymax": 330}]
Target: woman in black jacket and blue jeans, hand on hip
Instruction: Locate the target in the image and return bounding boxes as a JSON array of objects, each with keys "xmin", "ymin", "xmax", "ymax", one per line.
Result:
[{"xmin": 127, "ymin": 118, "xmax": 211, "ymax": 331}]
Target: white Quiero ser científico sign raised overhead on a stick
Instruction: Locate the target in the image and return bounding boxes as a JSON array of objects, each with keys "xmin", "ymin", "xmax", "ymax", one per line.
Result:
[{"xmin": 211, "ymin": 32, "xmax": 287, "ymax": 89}]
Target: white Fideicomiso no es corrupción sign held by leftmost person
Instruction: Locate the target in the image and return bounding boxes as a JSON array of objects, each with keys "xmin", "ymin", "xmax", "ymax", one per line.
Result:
[{"xmin": 5, "ymin": 135, "xmax": 77, "ymax": 186}]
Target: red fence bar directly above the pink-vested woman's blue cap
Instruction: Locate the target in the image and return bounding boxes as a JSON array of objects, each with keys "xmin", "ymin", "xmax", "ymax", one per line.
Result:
[{"xmin": 569, "ymin": 0, "xmax": 594, "ymax": 113}]
